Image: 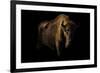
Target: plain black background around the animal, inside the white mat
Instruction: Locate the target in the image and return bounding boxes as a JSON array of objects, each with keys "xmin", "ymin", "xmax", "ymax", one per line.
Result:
[{"xmin": 21, "ymin": 10, "xmax": 90, "ymax": 62}]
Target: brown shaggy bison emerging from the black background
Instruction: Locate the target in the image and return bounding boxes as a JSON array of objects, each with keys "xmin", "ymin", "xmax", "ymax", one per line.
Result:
[{"xmin": 37, "ymin": 14, "xmax": 72, "ymax": 56}]
